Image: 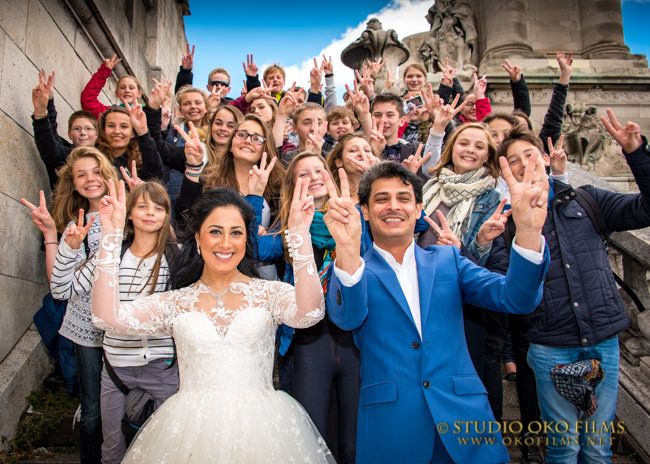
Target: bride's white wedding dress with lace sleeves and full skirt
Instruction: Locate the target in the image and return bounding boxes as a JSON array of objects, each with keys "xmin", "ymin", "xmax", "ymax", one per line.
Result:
[{"xmin": 93, "ymin": 227, "xmax": 335, "ymax": 464}]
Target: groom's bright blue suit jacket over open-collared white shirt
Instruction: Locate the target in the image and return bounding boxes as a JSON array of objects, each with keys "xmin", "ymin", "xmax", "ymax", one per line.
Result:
[{"xmin": 327, "ymin": 241, "xmax": 549, "ymax": 464}]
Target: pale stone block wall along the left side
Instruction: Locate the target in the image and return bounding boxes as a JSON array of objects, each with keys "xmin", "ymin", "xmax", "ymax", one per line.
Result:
[{"xmin": 0, "ymin": 0, "xmax": 189, "ymax": 446}]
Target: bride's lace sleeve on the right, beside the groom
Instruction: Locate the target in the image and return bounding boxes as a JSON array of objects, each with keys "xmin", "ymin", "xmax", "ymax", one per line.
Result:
[{"xmin": 269, "ymin": 227, "xmax": 325, "ymax": 329}]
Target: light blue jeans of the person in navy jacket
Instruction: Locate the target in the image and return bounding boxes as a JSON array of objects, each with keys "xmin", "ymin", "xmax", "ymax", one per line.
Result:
[{"xmin": 528, "ymin": 337, "xmax": 619, "ymax": 464}]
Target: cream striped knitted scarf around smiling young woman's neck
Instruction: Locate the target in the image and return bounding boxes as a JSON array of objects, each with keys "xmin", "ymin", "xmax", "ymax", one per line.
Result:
[{"xmin": 422, "ymin": 167, "xmax": 495, "ymax": 240}]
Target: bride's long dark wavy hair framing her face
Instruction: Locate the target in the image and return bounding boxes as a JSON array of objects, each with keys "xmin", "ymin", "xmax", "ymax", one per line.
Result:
[{"xmin": 170, "ymin": 187, "xmax": 259, "ymax": 289}]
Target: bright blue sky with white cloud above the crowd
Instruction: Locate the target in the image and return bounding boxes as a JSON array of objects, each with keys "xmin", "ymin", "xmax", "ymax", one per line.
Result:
[{"xmin": 179, "ymin": 0, "xmax": 650, "ymax": 102}]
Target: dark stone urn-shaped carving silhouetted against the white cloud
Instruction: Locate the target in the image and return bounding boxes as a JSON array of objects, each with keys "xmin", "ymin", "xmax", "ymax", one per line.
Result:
[{"xmin": 341, "ymin": 18, "xmax": 410, "ymax": 69}]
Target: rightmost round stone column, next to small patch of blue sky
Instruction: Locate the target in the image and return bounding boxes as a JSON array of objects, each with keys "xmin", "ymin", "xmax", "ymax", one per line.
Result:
[{"xmin": 580, "ymin": 0, "xmax": 630, "ymax": 57}]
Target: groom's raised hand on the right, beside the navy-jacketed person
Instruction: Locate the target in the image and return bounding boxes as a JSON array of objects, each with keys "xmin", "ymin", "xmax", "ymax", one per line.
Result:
[{"xmin": 499, "ymin": 153, "xmax": 549, "ymax": 252}]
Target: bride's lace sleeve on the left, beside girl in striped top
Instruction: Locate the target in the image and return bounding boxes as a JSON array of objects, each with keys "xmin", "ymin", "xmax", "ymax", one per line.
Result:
[{"xmin": 92, "ymin": 228, "xmax": 175, "ymax": 335}]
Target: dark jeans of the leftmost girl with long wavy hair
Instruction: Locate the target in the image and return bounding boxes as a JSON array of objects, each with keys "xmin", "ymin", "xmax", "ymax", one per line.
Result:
[{"xmin": 74, "ymin": 343, "xmax": 103, "ymax": 464}]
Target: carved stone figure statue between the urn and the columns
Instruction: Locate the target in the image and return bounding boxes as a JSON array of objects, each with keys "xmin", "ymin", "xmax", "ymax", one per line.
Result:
[{"xmin": 420, "ymin": 0, "xmax": 478, "ymax": 72}]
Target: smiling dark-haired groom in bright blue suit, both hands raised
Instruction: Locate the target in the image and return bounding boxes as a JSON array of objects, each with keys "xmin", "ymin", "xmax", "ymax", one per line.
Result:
[{"xmin": 325, "ymin": 160, "xmax": 549, "ymax": 464}]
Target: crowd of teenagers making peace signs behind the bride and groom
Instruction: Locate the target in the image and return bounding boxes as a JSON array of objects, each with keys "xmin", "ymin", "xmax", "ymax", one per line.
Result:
[{"xmin": 23, "ymin": 40, "xmax": 650, "ymax": 463}]
